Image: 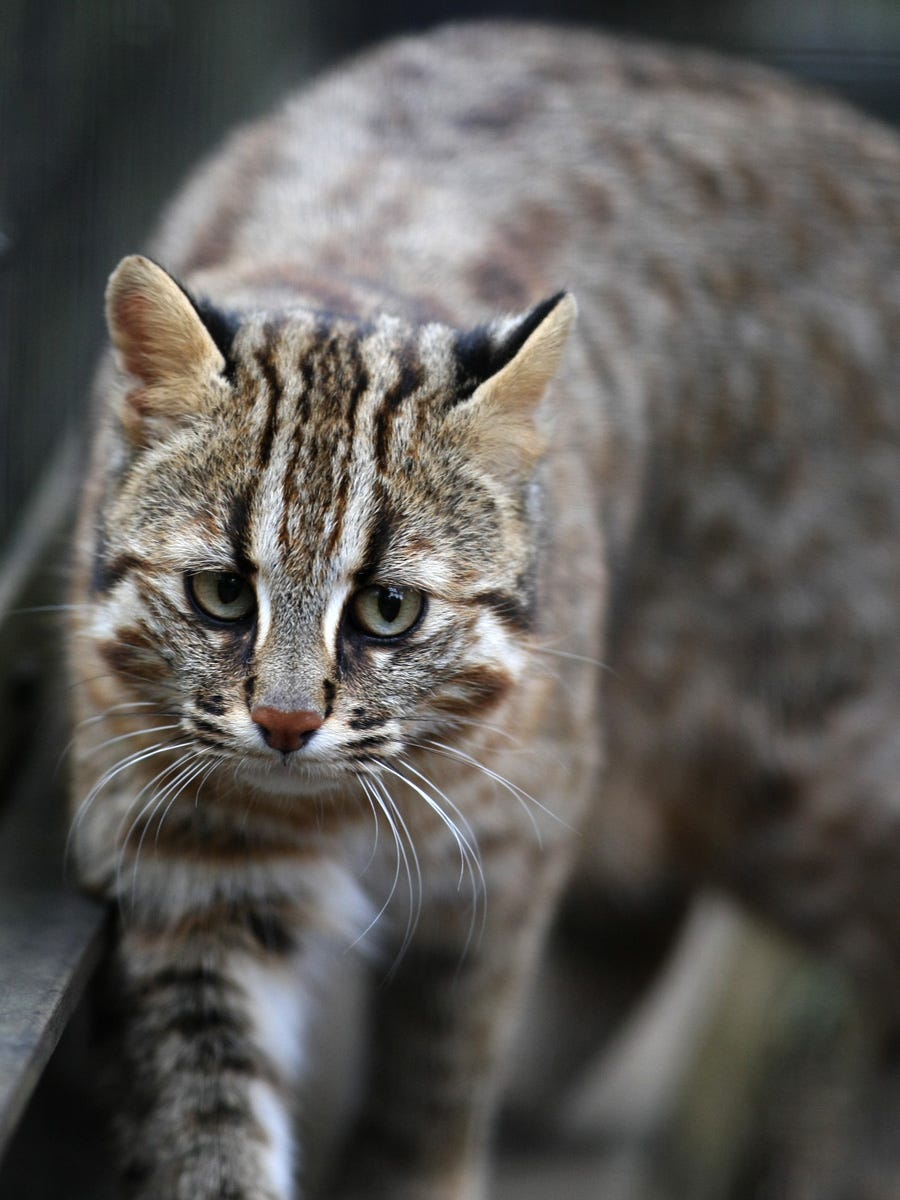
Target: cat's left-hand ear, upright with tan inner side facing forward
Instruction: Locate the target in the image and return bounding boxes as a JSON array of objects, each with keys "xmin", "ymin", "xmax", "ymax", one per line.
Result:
[{"xmin": 106, "ymin": 254, "xmax": 226, "ymax": 445}]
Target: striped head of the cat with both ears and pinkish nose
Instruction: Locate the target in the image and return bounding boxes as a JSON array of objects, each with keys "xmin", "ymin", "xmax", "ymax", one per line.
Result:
[{"xmin": 91, "ymin": 257, "xmax": 575, "ymax": 792}]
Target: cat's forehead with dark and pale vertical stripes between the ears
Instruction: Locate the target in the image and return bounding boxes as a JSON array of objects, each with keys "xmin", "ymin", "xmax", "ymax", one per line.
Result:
[{"xmin": 226, "ymin": 317, "xmax": 448, "ymax": 589}]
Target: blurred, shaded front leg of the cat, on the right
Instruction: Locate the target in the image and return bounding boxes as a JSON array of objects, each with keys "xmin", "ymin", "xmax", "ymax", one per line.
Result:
[{"xmin": 337, "ymin": 847, "xmax": 571, "ymax": 1200}]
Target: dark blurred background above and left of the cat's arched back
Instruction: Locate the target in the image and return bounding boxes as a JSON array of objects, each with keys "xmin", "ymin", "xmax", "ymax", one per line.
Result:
[{"xmin": 0, "ymin": 0, "xmax": 900, "ymax": 546}]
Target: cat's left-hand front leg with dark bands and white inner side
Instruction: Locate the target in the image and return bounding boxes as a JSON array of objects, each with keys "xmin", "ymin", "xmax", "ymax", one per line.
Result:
[{"xmin": 106, "ymin": 914, "xmax": 306, "ymax": 1200}]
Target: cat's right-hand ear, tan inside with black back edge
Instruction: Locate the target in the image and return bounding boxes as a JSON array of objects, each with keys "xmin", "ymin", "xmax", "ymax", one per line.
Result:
[{"xmin": 451, "ymin": 292, "xmax": 577, "ymax": 475}]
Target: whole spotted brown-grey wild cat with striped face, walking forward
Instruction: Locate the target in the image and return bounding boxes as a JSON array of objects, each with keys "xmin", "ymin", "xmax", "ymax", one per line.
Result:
[{"xmin": 71, "ymin": 24, "xmax": 900, "ymax": 1200}]
